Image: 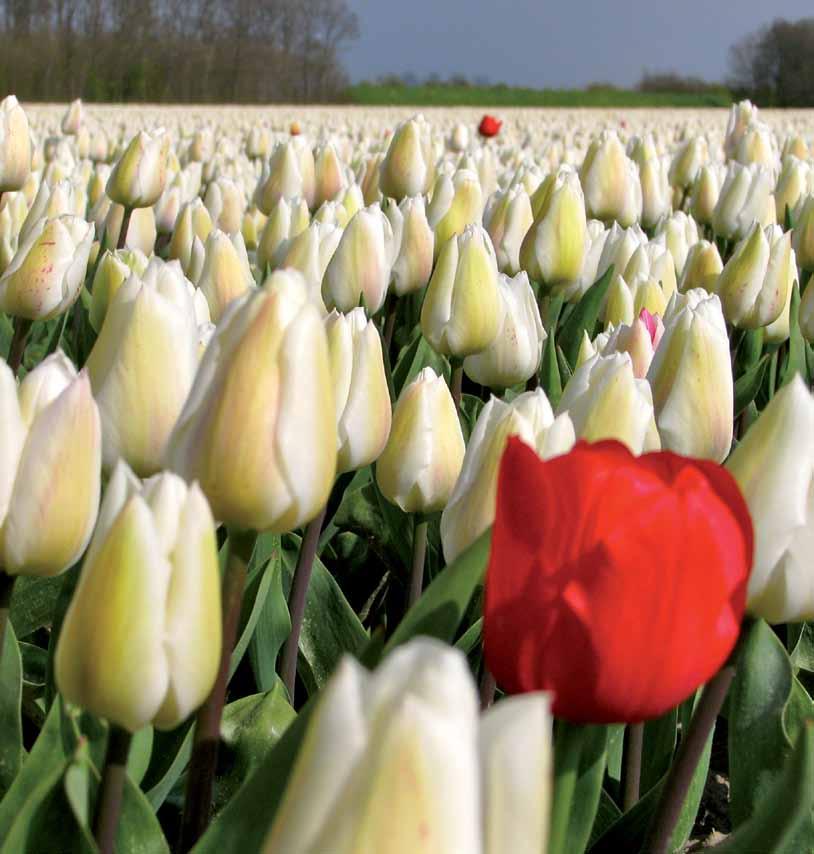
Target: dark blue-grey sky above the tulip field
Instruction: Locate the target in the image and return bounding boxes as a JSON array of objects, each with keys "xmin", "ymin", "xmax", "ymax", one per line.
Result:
[{"xmin": 345, "ymin": 0, "xmax": 814, "ymax": 88}]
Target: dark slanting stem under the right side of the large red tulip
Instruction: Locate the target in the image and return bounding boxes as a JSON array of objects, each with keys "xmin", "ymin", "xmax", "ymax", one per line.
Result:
[{"xmin": 642, "ymin": 659, "xmax": 735, "ymax": 854}]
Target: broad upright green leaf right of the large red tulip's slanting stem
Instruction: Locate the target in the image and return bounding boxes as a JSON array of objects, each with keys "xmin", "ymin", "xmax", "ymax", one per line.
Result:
[{"xmin": 729, "ymin": 620, "xmax": 792, "ymax": 827}]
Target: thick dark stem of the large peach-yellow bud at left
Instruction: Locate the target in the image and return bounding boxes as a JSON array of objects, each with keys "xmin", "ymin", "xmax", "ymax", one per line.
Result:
[{"xmin": 180, "ymin": 531, "xmax": 254, "ymax": 852}]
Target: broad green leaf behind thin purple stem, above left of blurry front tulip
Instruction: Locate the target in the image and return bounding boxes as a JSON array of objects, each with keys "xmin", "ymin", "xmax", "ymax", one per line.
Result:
[{"xmin": 282, "ymin": 549, "xmax": 369, "ymax": 694}]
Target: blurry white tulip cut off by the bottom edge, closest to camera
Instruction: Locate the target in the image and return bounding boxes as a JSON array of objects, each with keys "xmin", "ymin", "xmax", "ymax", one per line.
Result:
[{"xmin": 263, "ymin": 637, "xmax": 552, "ymax": 854}]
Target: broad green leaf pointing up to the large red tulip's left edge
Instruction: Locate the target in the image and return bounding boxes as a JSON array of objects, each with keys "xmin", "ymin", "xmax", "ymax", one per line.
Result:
[{"xmin": 385, "ymin": 528, "xmax": 492, "ymax": 653}]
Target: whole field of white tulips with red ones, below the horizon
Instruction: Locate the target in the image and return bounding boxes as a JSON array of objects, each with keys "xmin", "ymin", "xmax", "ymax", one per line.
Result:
[{"xmin": 0, "ymin": 95, "xmax": 814, "ymax": 854}]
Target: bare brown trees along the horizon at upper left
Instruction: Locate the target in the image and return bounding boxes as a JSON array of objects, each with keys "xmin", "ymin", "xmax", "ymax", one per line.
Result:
[{"xmin": 0, "ymin": 0, "xmax": 359, "ymax": 103}]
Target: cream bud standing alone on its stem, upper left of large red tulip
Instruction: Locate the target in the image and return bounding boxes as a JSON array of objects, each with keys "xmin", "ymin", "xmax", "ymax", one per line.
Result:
[{"xmin": 376, "ymin": 368, "xmax": 465, "ymax": 513}]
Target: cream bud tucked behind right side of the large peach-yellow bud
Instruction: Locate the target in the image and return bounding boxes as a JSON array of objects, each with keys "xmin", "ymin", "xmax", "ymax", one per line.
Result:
[{"xmin": 325, "ymin": 308, "xmax": 392, "ymax": 472}]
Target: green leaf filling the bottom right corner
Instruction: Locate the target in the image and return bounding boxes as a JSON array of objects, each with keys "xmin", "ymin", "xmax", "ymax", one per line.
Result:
[{"xmin": 714, "ymin": 720, "xmax": 814, "ymax": 854}]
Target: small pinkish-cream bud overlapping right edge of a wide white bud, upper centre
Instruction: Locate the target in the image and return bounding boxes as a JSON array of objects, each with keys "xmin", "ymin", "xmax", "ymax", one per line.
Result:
[{"xmin": 385, "ymin": 196, "xmax": 435, "ymax": 296}]
